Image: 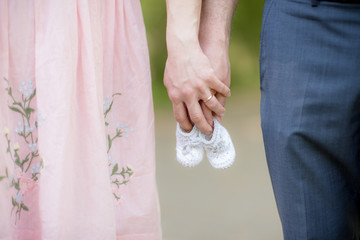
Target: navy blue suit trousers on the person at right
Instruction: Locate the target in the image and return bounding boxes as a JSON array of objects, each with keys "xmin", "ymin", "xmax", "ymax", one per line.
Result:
[{"xmin": 260, "ymin": 0, "xmax": 360, "ymax": 240}]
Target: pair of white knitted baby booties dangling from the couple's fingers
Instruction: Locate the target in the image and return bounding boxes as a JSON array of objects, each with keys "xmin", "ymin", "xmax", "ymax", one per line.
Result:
[{"xmin": 176, "ymin": 118, "xmax": 236, "ymax": 169}]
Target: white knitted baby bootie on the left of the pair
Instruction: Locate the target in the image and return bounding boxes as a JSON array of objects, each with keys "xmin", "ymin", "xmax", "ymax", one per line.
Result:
[{"xmin": 176, "ymin": 123, "xmax": 204, "ymax": 167}]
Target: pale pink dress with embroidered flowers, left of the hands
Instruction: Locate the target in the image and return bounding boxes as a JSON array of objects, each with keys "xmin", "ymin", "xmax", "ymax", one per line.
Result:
[{"xmin": 0, "ymin": 0, "xmax": 161, "ymax": 240}]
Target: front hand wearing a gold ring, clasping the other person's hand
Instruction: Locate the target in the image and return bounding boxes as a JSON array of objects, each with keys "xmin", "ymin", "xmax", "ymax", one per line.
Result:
[{"xmin": 164, "ymin": 45, "xmax": 230, "ymax": 134}]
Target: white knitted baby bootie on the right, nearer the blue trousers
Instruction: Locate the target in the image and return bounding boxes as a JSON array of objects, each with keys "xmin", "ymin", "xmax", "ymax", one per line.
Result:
[{"xmin": 201, "ymin": 118, "xmax": 236, "ymax": 169}]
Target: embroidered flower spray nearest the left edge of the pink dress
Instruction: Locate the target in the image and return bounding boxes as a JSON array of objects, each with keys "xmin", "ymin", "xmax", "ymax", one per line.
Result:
[{"xmin": 0, "ymin": 78, "xmax": 46, "ymax": 224}]
